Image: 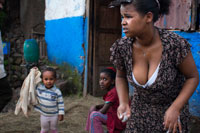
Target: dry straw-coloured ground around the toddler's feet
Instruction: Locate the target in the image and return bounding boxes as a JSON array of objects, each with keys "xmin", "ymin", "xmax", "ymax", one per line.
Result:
[{"xmin": 0, "ymin": 95, "xmax": 103, "ymax": 133}]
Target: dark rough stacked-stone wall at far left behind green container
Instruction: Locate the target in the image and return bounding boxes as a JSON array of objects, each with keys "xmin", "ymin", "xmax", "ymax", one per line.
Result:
[{"xmin": 3, "ymin": 20, "xmax": 26, "ymax": 89}]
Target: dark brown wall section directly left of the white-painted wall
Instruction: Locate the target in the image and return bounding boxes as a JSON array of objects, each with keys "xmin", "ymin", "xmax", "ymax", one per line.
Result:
[{"xmin": 20, "ymin": 0, "xmax": 45, "ymax": 39}]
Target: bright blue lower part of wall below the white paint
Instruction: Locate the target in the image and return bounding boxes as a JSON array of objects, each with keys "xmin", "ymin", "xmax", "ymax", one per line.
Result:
[{"xmin": 45, "ymin": 16, "xmax": 87, "ymax": 72}]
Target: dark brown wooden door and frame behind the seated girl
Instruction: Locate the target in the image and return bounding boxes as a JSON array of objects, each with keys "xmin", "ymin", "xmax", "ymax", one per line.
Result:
[{"xmin": 88, "ymin": 0, "xmax": 121, "ymax": 96}]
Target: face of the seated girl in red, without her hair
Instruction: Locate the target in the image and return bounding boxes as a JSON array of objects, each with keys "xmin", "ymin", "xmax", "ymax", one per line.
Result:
[{"xmin": 99, "ymin": 72, "xmax": 114, "ymax": 90}]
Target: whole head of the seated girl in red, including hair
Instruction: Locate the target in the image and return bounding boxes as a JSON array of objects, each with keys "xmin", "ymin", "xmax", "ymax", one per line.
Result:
[{"xmin": 99, "ymin": 67, "xmax": 116, "ymax": 91}]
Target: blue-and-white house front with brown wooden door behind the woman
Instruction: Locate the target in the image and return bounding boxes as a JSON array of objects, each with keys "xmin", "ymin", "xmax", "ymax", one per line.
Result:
[{"xmin": 45, "ymin": 0, "xmax": 200, "ymax": 117}]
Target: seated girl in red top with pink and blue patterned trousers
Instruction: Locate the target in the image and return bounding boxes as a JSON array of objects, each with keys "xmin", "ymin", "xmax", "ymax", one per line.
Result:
[{"xmin": 86, "ymin": 67, "xmax": 126, "ymax": 133}]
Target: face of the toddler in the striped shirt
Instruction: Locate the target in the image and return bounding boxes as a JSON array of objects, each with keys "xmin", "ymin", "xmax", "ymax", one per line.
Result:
[{"xmin": 42, "ymin": 71, "xmax": 56, "ymax": 89}]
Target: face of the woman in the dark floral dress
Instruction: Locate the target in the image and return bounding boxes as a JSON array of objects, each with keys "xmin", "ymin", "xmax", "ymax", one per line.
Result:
[{"xmin": 120, "ymin": 4, "xmax": 146, "ymax": 37}]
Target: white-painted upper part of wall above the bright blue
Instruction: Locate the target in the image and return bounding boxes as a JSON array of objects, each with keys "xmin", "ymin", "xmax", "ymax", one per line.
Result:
[{"xmin": 45, "ymin": 0, "xmax": 86, "ymax": 20}]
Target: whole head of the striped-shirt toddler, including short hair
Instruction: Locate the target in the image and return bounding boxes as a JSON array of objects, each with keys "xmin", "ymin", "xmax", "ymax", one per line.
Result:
[{"xmin": 41, "ymin": 67, "xmax": 56, "ymax": 89}]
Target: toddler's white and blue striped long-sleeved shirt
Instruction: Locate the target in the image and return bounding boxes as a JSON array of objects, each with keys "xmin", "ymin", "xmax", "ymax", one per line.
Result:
[{"xmin": 35, "ymin": 84, "xmax": 65, "ymax": 116}]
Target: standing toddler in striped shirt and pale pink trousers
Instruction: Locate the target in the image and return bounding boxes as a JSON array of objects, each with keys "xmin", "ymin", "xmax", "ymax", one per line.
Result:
[{"xmin": 35, "ymin": 68, "xmax": 64, "ymax": 133}]
